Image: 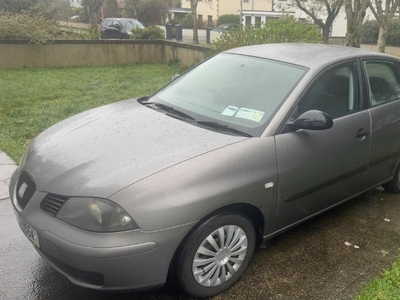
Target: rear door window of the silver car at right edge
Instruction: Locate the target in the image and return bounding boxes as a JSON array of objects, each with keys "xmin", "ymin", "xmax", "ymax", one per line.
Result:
[{"xmin": 364, "ymin": 60, "xmax": 400, "ymax": 107}]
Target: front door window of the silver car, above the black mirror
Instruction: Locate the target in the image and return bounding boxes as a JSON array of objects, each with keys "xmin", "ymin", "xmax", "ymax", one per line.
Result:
[{"xmin": 299, "ymin": 64, "xmax": 359, "ymax": 118}]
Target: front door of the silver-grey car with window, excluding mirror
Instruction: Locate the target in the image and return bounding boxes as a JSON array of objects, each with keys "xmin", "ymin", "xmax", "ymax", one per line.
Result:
[{"xmin": 275, "ymin": 60, "xmax": 370, "ymax": 230}]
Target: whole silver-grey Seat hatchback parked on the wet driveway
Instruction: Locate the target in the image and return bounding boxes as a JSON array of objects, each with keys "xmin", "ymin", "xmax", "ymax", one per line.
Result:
[{"xmin": 10, "ymin": 44, "xmax": 400, "ymax": 297}]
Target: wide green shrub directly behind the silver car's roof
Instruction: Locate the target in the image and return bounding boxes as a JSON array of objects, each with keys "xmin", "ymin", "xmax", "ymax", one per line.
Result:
[{"xmin": 212, "ymin": 17, "xmax": 323, "ymax": 53}]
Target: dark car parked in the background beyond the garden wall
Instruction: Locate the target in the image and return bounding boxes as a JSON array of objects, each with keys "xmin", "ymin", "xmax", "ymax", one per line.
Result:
[{"xmin": 100, "ymin": 18, "xmax": 144, "ymax": 39}]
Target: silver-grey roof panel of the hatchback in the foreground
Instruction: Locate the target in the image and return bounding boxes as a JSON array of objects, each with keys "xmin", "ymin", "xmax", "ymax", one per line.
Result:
[{"xmin": 225, "ymin": 43, "xmax": 398, "ymax": 69}]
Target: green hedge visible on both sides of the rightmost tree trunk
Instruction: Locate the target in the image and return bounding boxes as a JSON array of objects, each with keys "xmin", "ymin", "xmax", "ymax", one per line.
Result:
[{"xmin": 361, "ymin": 19, "xmax": 400, "ymax": 46}]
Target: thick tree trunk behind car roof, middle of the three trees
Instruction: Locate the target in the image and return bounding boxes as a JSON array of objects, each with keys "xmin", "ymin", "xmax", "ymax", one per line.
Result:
[{"xmin": 344, "ymin": 0, "xmax": 370, "ymax": 48}]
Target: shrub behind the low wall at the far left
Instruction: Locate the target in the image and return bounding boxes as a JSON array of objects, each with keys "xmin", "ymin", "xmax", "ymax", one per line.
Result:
[{"xmin": 0, "ymin": 11, "xmax": 58, "ymax": 44}]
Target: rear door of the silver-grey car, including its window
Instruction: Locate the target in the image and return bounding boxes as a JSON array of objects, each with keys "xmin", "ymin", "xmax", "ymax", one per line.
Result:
[{"xmin": 362, "ymin": 58, "xmax": 400, "ymax": 189}]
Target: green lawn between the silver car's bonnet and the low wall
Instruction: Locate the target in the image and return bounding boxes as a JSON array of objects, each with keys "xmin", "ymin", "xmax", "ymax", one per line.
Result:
[{"xmin": 0, "ymin": 64, "xmax": 179, "ymax": 162}]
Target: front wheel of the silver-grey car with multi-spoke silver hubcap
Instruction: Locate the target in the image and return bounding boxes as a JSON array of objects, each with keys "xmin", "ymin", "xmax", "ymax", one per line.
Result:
[{"xmin": 176, "ymin": 214, "xmax": 256, "ymax": 298}]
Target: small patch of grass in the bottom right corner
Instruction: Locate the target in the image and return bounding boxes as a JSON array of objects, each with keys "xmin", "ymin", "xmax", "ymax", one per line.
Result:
[{"xmin": 356, "ymin": 256, "xmax": 400, "ymax": 300}]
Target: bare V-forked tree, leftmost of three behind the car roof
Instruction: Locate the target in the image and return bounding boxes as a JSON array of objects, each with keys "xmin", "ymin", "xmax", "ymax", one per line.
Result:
[{"xmin": 293, "ymin": 0, "xmax": 344, "ymax": 44}]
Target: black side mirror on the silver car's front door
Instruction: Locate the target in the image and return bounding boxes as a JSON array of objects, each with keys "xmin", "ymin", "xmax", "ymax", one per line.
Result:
[{"xmin": 287, "ymin": 110, "xmax": 333, "ymax": 130}]
